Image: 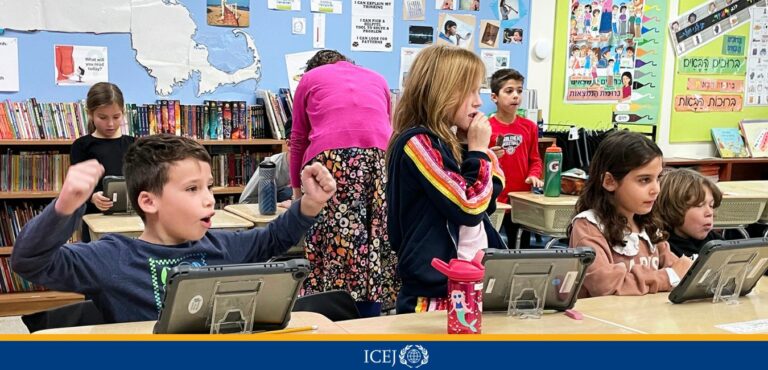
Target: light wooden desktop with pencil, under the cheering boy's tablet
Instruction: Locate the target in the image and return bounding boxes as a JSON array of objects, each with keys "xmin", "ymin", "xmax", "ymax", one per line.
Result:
[{"xmin": 34, "ymin": 312, "xmax": 346, "ymax": 334}]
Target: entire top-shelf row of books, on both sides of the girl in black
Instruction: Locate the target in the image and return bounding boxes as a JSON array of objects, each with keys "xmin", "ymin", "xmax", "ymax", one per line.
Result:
[{"xmin": 0, "ymin": 89, "xmax": 293, "ymax": 140}]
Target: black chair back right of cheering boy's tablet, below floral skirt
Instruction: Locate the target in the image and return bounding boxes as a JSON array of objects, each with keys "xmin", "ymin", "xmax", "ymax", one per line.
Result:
[{"xmin": 293, "ymin": 290, "xmax": 360, "ymax": 321}]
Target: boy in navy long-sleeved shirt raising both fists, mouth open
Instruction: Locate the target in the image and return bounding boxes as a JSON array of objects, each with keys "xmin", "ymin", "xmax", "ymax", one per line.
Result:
[{"xmin": 11, "ymin": 135, "xmax": 336, "ymax": 322}]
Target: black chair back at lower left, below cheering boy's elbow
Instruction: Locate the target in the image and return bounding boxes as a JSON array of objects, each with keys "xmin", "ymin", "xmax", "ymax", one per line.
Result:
[{"xmin": 21, "ymin": 300, "xmax": 106, "ymax": 333}]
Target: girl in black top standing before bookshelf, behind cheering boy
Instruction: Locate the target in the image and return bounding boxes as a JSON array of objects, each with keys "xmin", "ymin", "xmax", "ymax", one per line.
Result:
[{"xmin": 69, "ymin": 82, "xmax": 135, "ymax": 242}]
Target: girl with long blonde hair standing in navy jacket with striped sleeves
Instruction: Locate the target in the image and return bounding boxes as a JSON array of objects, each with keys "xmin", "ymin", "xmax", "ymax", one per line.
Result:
[{"xmin": 386, "ymin": 45, "xmax": 505, "ymax": 313}]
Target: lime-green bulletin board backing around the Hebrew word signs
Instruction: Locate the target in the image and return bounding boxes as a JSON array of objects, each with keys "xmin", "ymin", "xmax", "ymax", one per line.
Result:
[{"xmin": 669, "ymin": 0, "xmax": 768, "ymax": 143}]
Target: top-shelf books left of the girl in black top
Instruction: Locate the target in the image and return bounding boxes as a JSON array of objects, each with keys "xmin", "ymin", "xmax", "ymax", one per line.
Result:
[{"xmin": 0, "ymin": 98, "xmax": 88, "ymax": 140}]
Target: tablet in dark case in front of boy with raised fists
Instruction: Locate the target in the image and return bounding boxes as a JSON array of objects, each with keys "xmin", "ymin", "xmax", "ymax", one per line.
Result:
[{"xmin": 154, "ymin": 259, "xmax": 309, "ymax": 334}]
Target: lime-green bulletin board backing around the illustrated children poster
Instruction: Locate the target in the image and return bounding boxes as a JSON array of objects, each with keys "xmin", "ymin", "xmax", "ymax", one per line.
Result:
[{"xmin": 549, "ymin": 0, "xmax": 667, "ymax": 129}]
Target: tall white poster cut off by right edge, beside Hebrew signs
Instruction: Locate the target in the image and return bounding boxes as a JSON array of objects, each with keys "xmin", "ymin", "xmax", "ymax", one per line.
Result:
[{"xmin": 744, "ymin": 7, "xmax": 768, "ymax": 107}]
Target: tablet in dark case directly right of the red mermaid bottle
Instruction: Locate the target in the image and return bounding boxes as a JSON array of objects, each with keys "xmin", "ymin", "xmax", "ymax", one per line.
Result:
[{"xmin": 483, "ymin": 247, "xmax": 595, "ymax": 311}]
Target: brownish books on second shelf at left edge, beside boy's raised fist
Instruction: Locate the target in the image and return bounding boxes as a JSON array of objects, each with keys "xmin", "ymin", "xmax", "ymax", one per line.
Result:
[{"xmin": 0, "ymin": 149, "xmax": 69, "ymax": 192}]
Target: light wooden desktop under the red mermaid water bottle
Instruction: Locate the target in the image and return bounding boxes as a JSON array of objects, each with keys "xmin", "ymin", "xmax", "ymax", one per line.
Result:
[{"xmin": 337, "ymin": 311, "xmax": 634, "ymax": 339}]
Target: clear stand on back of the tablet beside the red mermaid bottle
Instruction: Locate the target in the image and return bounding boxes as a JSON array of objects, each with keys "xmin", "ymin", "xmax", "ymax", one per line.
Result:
[{"xmin": 507, "ymin": 264, "xmax": 554, "ymax": 319}]
